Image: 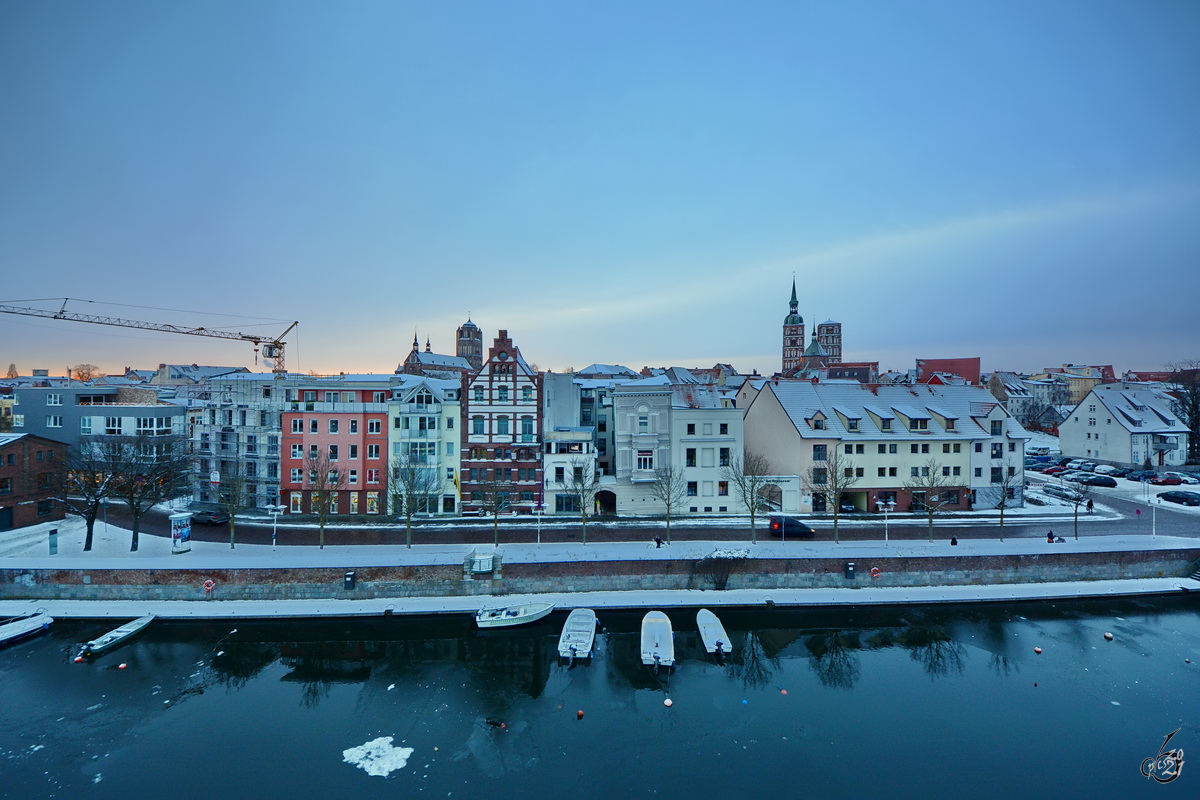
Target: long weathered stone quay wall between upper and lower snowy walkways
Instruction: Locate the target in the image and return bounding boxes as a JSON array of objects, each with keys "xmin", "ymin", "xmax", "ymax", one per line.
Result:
[{"xmin": 0, "ymin": 548, "xmax": 1200, "ymax": 601}]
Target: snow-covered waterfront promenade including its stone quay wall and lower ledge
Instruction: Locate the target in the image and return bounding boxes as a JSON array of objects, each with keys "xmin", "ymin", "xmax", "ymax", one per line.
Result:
[{"xmin": 0, "ymin": 510, "xmax": 1200, "ymax": 619}]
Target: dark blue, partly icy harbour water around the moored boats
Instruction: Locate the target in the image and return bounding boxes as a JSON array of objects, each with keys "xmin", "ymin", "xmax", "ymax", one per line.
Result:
[{"xmin": 0, "ymin": 597, "xmax": 1200, "ymax": 800}]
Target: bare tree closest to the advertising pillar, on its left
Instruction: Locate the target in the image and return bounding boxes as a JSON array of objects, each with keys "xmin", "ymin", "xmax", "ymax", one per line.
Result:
[{"xmin": 103, "ymin": 435, "xmax": 192, "ymax": 552}]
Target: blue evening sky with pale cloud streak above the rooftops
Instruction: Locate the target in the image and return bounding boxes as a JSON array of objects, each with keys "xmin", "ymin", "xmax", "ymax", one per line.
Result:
[{"xmin": 0, "ymin": 0, "xmax": 1200, "ymax": 374}]
